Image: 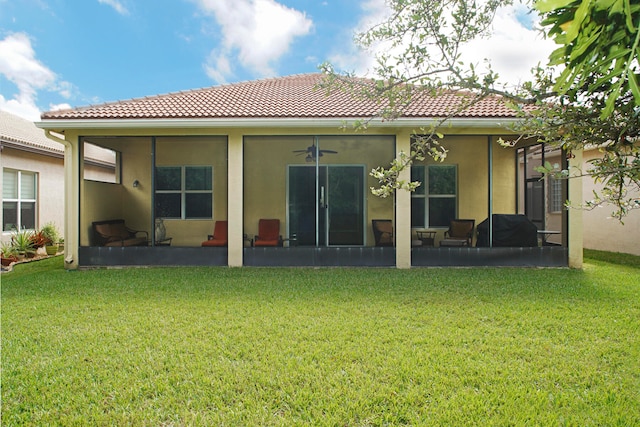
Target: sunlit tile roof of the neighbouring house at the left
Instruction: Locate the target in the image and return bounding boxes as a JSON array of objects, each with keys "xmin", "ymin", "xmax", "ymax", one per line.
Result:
[{"xmin": 0, "ymin": 111, "xmax": 64, "ymax": 154}]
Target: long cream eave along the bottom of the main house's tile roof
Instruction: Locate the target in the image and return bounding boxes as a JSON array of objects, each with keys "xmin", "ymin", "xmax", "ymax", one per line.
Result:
[{"xmin": 35, "ymin": 117, "xmax": 520, "ymax": 131}]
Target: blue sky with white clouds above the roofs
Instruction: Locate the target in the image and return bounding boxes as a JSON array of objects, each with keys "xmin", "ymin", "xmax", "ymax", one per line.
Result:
[{"xmin": 0, "ymin": 0, "xmax": 553, "ymax": 121}]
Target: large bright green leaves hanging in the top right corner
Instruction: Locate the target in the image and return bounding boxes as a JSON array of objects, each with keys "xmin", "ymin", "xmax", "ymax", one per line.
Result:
[{"xmin": 535, "ymin": 0, "xmax": 640, "ymax": 119}]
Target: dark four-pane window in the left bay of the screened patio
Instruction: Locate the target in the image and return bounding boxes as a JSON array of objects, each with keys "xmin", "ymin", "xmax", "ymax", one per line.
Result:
[{"xmin": 155, "ymin": 166, "xmax": 213, "ymax": 219}]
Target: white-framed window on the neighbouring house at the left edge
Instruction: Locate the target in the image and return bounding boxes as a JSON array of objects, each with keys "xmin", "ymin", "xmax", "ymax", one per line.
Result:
[{"xmin": 2, "ymin": 169, "xmax": 38, "ymax": 231}]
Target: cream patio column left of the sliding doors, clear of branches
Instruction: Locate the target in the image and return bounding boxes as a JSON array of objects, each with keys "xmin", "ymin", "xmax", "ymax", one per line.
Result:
[{"xmin": 227, "ymin": 131, "xmax": 244, "ymax": 267}]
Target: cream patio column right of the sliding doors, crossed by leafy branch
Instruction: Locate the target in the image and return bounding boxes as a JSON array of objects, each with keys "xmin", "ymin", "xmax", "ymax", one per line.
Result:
[{"xmin": 395, "ymin": 130, "xmax": 411, "ymax": 268}]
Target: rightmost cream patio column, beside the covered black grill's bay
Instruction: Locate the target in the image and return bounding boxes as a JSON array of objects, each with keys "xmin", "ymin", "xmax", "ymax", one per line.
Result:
[{"xmin": 567, "ymin": 150, "xmax": 583, "ymax": 268}]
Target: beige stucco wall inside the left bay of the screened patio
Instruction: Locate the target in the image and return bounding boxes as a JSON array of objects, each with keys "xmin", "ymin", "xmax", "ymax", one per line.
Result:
[{"xmin": 81, "ymin": 136, "xmax": 227, "ymax": 246}]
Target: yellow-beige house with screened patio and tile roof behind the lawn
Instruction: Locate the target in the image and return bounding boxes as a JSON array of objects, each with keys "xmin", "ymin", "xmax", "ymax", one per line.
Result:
[{"xmin": 38, "ymin": 74, "xmax": 582, "ymax": 269}]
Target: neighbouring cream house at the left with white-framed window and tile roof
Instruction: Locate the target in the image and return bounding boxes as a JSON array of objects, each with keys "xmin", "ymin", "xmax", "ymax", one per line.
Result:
[{"xmin": 0, "ymin": 111, "xmax": 115, "ymax": 246}]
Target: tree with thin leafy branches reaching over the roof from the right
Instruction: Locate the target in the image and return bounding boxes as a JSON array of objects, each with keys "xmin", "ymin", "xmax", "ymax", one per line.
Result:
[{"xmin": 323, "ymin": 0, "xmax": 640, "ymax": 218}]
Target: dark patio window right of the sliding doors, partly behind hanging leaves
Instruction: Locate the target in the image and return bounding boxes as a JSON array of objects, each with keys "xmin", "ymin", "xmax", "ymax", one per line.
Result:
[{"xmin": 411, "ymin": 165, "xmax": 458, "ymax": 228}]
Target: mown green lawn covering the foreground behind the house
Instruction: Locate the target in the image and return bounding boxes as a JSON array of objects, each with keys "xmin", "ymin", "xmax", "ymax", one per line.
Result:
[{"xmin": 2, "ymin": 252, "xmax": 640, "ymax": 426}]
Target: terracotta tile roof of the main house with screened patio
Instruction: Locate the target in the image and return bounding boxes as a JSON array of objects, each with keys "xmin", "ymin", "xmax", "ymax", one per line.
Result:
[{"xmin": 42, "ymin": 73, "xmax": 514, "ymax": 120}]
